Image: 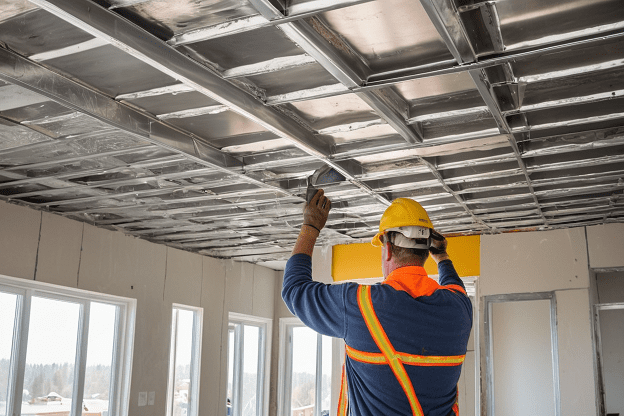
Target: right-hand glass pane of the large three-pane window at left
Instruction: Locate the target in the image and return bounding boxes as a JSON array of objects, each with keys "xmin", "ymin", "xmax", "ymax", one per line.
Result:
[{"xmin": 82, "ymin": 302, "xmax": 117, "ymax": 416}]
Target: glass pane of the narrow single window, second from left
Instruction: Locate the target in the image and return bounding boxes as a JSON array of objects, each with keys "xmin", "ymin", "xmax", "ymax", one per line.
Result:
[{"xmin": 173, "ymin": 309, "xmax": 193, "ymax": 416}]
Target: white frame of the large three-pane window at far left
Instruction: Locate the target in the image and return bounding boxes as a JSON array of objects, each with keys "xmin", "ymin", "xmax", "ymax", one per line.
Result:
[{"xmin": 0, "ymin": 275, "xmax": 137, "ymax": 416}]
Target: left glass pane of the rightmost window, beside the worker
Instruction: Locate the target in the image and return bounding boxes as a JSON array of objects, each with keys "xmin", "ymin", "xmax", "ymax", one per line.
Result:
[{"xmin": 290, "ymin": 326, "xmax": 317, "ymax": 416}]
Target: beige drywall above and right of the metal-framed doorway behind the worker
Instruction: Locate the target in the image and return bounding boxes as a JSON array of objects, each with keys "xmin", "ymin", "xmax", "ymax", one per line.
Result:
[{"xmin": 478, "ymin": 228, "xmax": 596, "ymax": 415}]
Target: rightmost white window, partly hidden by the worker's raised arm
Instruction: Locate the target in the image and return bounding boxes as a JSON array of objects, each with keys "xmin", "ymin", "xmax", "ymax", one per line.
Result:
[{"xmin": 279, "ymin": 318, "xmax": 332, "ymax": 416}]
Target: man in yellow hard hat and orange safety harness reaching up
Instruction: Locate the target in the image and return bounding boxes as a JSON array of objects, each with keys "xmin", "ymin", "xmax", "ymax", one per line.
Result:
[{"xmin": 282, "ymin": 190, "xmax": 472, "ymax": 416}]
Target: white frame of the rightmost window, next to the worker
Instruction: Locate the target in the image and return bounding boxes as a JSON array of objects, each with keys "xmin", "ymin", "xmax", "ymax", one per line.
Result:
[{"xmin": 277, "ymin": 318, "xmax": 336, "ymax": 416}]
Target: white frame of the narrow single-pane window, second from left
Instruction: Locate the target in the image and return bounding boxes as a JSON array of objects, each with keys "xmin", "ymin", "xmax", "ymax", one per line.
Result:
[{"xmin": 167, "ymin": 303, "xmax": 204, "ymax": 416}]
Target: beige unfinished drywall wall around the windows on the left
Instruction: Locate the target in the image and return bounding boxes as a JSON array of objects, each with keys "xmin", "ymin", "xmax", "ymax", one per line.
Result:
[{"xmin": 0, "ymin": 202, "xmax": 279, "ymax": 416}]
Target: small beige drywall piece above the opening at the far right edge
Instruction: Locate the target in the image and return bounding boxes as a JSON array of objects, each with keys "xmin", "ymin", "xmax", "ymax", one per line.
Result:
[{"xmin": 587, "ymin": 224, "xmax": 624, "ymax": 269}]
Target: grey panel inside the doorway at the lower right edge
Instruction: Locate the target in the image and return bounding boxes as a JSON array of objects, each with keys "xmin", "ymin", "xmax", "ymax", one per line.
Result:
[{"xmin": 599, "ymin": 309, "xmax": 624, "ymax": 415}]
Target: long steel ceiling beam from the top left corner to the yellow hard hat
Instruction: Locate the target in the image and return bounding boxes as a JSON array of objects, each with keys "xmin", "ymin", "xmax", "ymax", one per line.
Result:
[{"xmin": 32, "ymin": 0, "xmax": 390, "ymax": 210}]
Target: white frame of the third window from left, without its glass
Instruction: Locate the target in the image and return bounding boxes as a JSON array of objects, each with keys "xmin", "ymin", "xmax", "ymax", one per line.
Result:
[{"xmin": 226, "ymin": 312, "xmax": 273, "ymax": 416}]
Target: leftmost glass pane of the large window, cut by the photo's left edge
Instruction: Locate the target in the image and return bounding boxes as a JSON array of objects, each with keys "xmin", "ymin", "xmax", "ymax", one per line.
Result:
[{"xmin": 0, "ymin": 292, "xmax": 17, "ymax": 416}]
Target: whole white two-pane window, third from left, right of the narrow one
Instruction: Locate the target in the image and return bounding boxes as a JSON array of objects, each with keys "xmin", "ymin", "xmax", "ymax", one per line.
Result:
[{"xmin": 226, "ymin": 313, "xmax": 271, "ymax": 416}]
